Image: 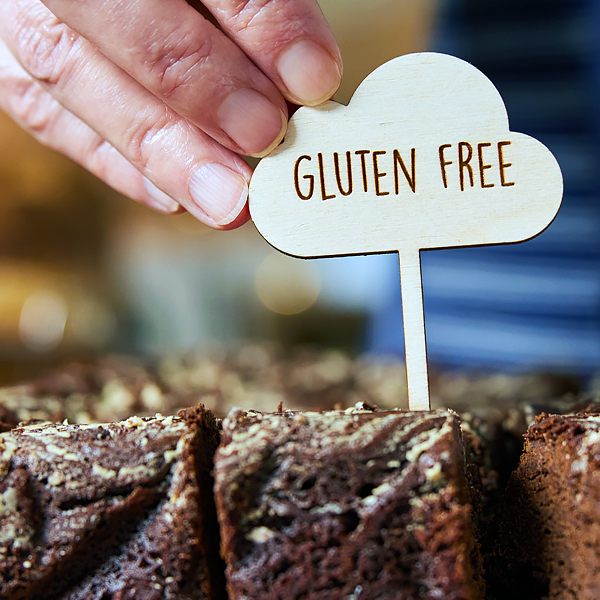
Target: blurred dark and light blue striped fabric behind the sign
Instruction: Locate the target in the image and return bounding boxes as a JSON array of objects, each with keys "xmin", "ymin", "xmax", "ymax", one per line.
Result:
[{"xmin": 369, "ymin": 0, "xmax": 600, "ymax": 376}]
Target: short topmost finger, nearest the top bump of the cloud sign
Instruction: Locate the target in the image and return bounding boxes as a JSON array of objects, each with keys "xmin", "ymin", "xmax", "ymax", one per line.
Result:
[{"xmin": 205, "ymin": 0, "xmax": 342, "ymax": 106}]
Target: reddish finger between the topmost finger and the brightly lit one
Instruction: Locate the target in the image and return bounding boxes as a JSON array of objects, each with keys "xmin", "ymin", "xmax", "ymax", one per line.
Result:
[{"xmin": 42, "ymin": 0, "xmax": 287, "ymax": 156}]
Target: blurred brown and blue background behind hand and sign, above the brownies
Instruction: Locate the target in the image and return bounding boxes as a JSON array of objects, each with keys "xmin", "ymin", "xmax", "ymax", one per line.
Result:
[{"xmin": 0, "ymin": 0, "xmax": 600, "ymax": 387}]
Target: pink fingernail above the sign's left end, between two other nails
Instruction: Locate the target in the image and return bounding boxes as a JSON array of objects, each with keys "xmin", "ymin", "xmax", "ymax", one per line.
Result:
[{"xmin": 217, "ymin": 88, "xmax": 287, "ymax": 156}]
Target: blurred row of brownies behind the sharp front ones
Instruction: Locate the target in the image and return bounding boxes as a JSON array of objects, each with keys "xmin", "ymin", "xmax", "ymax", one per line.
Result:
[{"xmin": 0, "ymin": 343, "xmax": 578, "ymax": 424}]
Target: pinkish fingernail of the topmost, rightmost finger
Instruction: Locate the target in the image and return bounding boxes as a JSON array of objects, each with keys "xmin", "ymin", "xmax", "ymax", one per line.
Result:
[{"xmin": 277, "ymin": 40, "xmax": 342, "ymax": 106}]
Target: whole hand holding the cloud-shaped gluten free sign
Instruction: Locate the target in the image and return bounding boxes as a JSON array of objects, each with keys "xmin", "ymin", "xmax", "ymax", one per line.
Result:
[{"xmin": 0, "ymin": 0, "xmax": 341, "ymax": 229}]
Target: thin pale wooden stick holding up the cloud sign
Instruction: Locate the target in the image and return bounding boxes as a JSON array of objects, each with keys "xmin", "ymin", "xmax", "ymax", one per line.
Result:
[{"xmin": 398, "ymin": 248, "xmax": 431, "ymax": 410}]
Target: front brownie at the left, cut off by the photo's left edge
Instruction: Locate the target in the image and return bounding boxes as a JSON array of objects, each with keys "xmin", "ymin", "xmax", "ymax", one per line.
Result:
[{"xmin": 0, "ymin": 407, "xmax": 225, "ymax": 600}]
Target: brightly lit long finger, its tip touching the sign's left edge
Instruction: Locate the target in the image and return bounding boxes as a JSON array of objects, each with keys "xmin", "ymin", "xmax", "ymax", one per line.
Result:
[{"xmin": 0, "ymin": 0, "xmax": 251, "ymax": 229}]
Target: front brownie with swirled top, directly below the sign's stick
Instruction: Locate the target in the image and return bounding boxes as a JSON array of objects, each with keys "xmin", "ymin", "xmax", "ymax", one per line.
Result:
[{"xmin": 215, "ymin": 406, "xmax": 480, "ymax": 600}]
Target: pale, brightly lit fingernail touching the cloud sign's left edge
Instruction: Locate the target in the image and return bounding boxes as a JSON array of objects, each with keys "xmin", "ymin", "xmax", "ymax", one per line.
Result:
[{"xmin": 188, "ymin": 163, "xmax": 248, "ymax": 225}]
